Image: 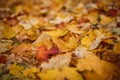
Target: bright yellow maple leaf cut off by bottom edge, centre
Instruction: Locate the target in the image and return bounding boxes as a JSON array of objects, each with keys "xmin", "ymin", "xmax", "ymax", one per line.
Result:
[{"xmin": 37, "ymin": 67, "xmax": 83, "ymax": 80}]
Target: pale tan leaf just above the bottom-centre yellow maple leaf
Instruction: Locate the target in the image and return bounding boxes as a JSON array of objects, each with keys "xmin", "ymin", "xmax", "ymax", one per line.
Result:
[{"xmin": 40, "ymin": 53, "xmax": 71, "ymax": 69}]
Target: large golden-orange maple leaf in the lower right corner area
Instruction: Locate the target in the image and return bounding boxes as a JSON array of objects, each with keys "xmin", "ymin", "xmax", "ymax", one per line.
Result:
[{"xmin": 77, "ymin": 54, "xmax": 115, "ymax": 80}]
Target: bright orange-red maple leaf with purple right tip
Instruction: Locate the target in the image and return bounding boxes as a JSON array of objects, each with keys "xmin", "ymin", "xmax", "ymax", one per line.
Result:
[{"xmin": 36, "ymin": 46, "xmax": 59, "ymax": 61}]
